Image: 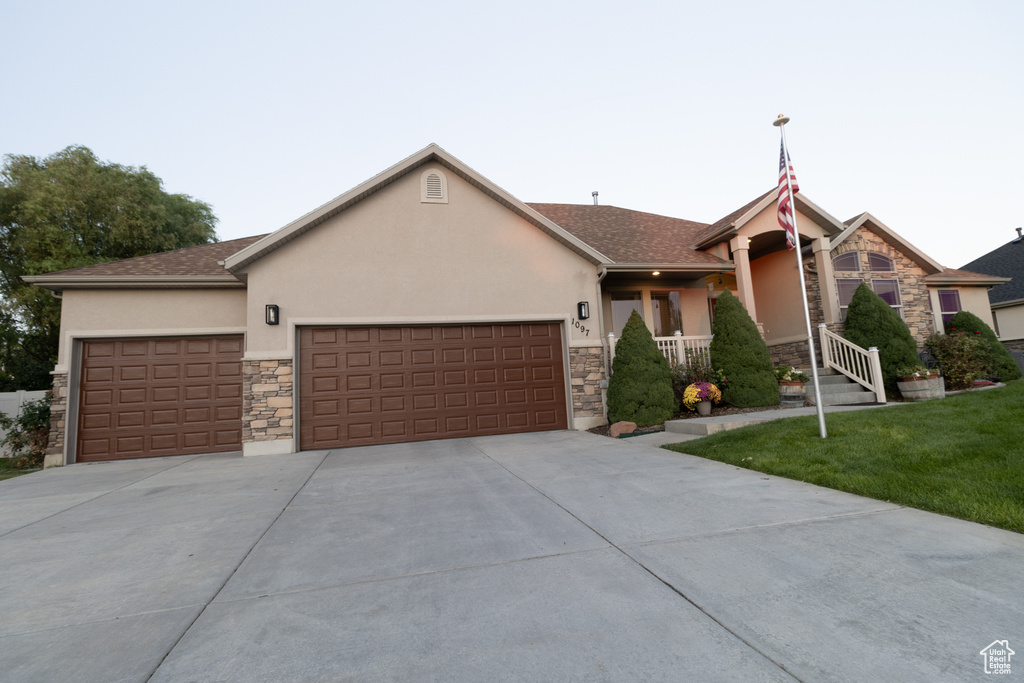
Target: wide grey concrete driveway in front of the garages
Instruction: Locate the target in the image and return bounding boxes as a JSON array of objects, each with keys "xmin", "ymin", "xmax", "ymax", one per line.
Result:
[{"xmin": 0, "ymin": 432, "xmax": 1024, "ymax": 682}]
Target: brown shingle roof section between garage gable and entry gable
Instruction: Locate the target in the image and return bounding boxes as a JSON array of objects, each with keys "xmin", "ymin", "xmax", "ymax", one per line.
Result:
[{"xmin": 527, "ymin": 204, "xmax": 723, "ymax": 265}]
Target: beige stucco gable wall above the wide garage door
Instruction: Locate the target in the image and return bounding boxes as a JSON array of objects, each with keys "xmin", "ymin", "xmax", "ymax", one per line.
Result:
[{"xmin": 241, "ymin": 165, "xmax": 600, "ymax": 358}]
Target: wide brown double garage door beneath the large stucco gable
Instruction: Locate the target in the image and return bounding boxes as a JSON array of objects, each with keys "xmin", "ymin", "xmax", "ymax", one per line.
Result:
[{"xmin": 299, "ymin": 323, "xmax": 568, "ymax": 450}]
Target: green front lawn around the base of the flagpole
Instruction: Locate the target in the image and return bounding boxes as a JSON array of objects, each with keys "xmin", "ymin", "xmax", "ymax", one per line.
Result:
[{"xmin": 665, "ymin": 380, "xmax": 1024, "ymax": 532}]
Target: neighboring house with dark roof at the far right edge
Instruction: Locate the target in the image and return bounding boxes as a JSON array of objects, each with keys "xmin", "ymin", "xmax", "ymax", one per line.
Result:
[{"xmin": 964, "ymin": 227, "xmax": 1024, "ymax": 351}]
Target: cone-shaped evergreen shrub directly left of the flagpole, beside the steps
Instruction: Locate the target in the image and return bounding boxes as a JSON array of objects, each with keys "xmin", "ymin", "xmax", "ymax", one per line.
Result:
[{"xmin": 711, "ymin": 290, "xmax": 779, "ymax": 408}]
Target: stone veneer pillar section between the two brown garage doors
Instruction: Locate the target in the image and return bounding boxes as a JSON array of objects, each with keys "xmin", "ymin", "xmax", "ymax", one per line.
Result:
[{"xmin": 242, "ymin": 358, "xmax": 295, "ymax": 443}]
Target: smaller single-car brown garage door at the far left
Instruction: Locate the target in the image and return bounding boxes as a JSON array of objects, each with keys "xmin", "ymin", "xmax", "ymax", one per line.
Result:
[{"xmin": 76, "ymin": 336, "xmax": 243, "ymax": 462}]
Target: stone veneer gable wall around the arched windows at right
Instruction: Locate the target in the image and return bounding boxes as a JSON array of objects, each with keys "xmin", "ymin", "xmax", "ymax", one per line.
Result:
[{"xmin": 831, "ymin": 227, "xmax": 935, "ymax": 348}]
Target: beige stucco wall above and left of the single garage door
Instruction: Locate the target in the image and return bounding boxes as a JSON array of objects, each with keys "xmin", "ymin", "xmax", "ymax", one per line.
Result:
[{"xmin": 57, "ymin": 289, "xmax": 246, "ymax": 372}]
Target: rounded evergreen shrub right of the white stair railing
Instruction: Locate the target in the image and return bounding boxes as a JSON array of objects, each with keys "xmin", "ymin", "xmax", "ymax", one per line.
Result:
[{"xmin": 845, "ymin": 283, "xmax": 921, "ymax": 398}]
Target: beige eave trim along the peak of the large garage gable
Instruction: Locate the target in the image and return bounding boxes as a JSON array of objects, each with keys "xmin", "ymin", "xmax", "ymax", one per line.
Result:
[{"xmin": 224, "ymin": 143, "xmax": 611, "ymax": 272}]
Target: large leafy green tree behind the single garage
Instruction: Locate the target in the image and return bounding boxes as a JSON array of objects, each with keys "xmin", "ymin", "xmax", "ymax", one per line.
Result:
[{"xmin": 0, "ymin": 146, "xmax": 217, "ymax": 378}]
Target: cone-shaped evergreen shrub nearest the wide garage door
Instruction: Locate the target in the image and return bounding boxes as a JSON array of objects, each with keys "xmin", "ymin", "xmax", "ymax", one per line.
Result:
[{"xmin": 608, "ymin": 311, "xmax": 679, "ymax": 427}]
